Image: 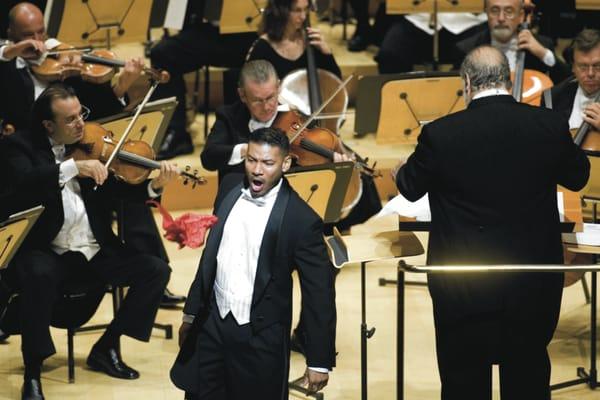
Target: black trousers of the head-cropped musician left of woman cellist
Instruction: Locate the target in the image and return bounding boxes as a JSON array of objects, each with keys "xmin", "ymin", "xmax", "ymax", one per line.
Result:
[{"xmin": 150, "ymin": 22, "xmax": 257, "ymax": 140}]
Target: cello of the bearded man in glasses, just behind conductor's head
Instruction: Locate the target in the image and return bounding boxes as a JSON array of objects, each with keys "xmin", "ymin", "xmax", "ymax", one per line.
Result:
[{"xmin": 511, "ymin": 2, "xmax": 554, "ymax": 106}]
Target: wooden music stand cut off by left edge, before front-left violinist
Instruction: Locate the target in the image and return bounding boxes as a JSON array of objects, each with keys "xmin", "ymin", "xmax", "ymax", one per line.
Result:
[{"xmin": 0, "ymin": 206, "xmax": 44, "ymax": 270}]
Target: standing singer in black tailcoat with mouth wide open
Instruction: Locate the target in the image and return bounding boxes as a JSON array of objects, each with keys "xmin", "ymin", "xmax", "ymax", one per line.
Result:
[{"xmin": 171, "ymin": 128, "xmax": 336, "ymax": 400}]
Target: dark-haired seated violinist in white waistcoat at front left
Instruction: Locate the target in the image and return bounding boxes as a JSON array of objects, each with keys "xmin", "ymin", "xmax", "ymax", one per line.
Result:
[{"xmin": 0, "ymin": 84, "xmax": 176, "ymax": 399}]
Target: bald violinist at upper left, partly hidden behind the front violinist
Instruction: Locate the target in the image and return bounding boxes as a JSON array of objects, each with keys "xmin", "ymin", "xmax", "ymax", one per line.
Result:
[{"xmin": 0, "ymin": 3, "xmax": 185, "ymax": 307}]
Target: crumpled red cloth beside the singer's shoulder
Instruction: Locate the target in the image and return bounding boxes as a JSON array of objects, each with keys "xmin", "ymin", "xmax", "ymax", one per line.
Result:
[{"xmin": 146, "ymin": 200, "xmax": 218, "ymax": 249}]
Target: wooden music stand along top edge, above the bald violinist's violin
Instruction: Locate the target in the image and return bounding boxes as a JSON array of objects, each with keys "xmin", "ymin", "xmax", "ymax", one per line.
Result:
[{"xmin": 44, "ymin": 0, "xmax": 155, "ymax": 49}]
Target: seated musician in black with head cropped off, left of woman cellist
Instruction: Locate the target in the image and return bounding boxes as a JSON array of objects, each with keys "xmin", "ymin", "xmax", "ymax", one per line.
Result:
[{"xmin": 150, "ymin": 0, "xmax": 256, "ymax": 159}]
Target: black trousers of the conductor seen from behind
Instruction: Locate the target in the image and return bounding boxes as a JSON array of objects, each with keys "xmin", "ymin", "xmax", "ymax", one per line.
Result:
[{"xmin": 432, "ymin": 274, "xmax": 563, "ymax": 400}]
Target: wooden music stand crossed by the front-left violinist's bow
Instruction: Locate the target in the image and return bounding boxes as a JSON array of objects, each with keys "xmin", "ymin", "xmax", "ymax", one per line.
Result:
[{"xmin": 96, "ymin": 97, "xmax": 177, "ymax": 153}]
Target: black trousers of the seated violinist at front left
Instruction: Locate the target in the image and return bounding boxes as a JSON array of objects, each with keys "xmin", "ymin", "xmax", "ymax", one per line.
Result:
[{"xmin": 11, "ymin": 250, "xmax": 171, "ymax": 362}]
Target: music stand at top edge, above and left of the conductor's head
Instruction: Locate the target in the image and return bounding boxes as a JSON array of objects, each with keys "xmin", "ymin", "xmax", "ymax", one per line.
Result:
[{"xmin": 386, "ymin": 0, "xmax": 483, "ymax": 70}]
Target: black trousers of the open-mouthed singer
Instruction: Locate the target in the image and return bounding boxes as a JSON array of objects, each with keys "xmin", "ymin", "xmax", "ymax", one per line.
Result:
[{"xmin": 186, "ymin": 301, "xmax": 289, "ymax": 400}]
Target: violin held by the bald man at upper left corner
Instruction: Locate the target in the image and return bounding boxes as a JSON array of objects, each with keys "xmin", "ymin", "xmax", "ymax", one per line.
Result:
[{"xmin": 31, "ymin": 44, "xmax": 170, "ymax": 84}]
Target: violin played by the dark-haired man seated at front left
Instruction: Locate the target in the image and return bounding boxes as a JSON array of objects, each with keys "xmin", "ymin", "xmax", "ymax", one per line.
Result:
[{"xmin": 69, "ymin": 122, "xmax": 206, "ymax": 188}]
